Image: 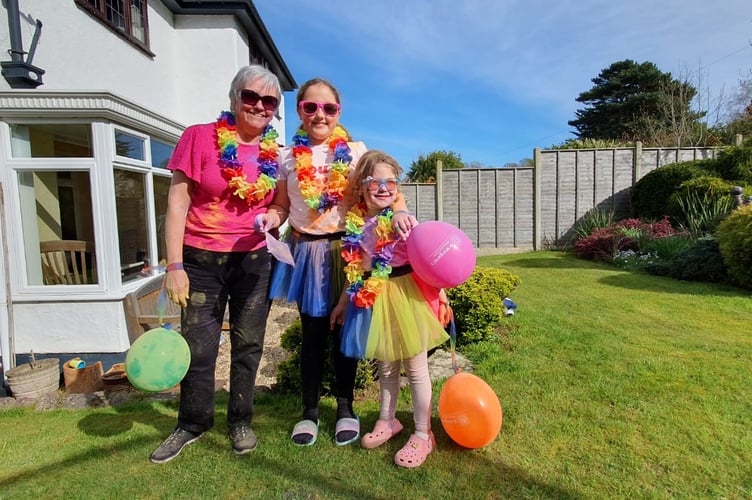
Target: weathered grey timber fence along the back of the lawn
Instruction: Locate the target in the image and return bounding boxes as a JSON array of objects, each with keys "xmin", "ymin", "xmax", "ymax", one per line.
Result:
[{"xmin": 402, "ymin": 144, "xmax": 717, "ymax": 253}]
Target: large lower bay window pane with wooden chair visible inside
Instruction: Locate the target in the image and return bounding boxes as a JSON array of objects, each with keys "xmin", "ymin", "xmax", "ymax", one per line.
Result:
[{"xmin": 18, "ymin": 171, "xmax": 97, "ymax": 285}]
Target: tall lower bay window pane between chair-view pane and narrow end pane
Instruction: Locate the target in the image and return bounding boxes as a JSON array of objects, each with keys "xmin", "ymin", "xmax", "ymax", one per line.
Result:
[{"xmin": 115, "ymin": 169, "xmax": 148, "ymax": 281}]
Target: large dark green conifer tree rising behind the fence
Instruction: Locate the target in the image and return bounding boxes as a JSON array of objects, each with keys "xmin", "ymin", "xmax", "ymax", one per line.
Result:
[{"xmin": 568, "ymin": 59, "xmax": 699, "ymax": 141}]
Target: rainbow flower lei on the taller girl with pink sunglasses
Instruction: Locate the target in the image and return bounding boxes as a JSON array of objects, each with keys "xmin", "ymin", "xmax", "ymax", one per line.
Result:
[{"xmin": 292, "ymin": 125, "xmax": 352, "ymax": 212}]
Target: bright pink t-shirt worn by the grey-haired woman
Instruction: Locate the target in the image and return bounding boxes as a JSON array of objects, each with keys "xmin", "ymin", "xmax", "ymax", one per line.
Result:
[{"xmin": 167, "ymin": 123, "xmax": 274, "ymax": 252}]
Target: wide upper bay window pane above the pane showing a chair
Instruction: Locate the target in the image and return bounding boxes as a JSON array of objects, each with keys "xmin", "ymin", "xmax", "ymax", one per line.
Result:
[{"xmin": 10, "ymin": 124, "xmax": 94, "ymax": 158}]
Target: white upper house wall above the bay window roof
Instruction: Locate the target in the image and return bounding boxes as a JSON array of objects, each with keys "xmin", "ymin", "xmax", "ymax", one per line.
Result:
[{"xmin": 0, "ymin": 0, "xmax": 285, "ymax": 137}]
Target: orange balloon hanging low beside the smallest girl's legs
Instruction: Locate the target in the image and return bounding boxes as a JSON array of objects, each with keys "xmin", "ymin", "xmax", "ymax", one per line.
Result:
[{"xmin": 439, "ymin": 372, "xmax": 502, "ymax": 448}]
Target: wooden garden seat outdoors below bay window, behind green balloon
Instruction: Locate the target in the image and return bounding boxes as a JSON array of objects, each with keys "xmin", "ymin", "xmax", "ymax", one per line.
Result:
[{"xmin": 123, "ymin": 275, "xmax": 180, "ymax": 344}]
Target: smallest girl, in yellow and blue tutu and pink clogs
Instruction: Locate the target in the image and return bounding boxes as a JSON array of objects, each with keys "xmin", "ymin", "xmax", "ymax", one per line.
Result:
[{"xmin": 331, "ymin": 151, "xmax": 449, "ymax": 467}]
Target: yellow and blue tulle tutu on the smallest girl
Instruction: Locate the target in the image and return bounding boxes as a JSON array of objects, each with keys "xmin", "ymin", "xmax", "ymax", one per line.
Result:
[{"xmin": 340, "ymin": 274, "xmax": 449, "ymax": 361}]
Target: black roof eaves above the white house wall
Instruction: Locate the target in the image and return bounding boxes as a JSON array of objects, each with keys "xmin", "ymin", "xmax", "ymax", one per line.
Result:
[{"xmin": 162, "ymin": 0, "xmax": 298, "ymax": 92}]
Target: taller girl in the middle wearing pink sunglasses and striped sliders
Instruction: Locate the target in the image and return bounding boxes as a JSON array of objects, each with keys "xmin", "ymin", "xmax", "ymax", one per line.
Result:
[{"xmin": 260, "ymin": 78, "xmax": 417, "ymax": 446}]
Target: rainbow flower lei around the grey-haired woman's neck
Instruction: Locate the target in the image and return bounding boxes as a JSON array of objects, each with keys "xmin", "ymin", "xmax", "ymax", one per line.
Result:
[{"xmin": 214, "ymin": 111, "xmax": 279, "ymax": 205}]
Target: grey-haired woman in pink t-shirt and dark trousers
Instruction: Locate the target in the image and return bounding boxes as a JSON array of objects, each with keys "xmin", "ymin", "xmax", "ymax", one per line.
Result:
[{"xmin": 150, "ymin": 66, "xmax": 287, "ymax": 463}]
